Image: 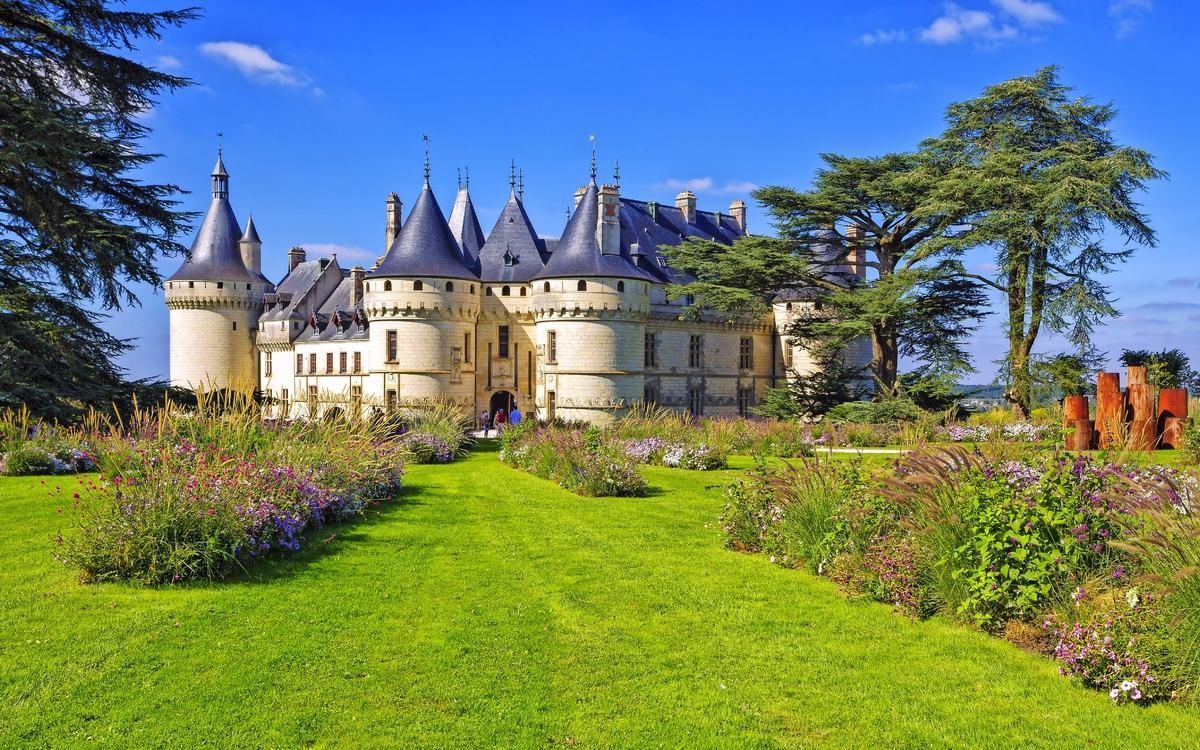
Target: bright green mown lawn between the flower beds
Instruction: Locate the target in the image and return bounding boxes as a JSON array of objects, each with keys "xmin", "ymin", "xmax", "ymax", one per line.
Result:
[{"xmin": 0, "ymin": 444, "xmax": 1200, "ymax": 749}]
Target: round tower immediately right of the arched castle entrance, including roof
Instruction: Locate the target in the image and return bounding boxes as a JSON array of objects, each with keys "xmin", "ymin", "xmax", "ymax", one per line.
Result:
[{"xmin": 533, "ymin": 172, "xmax": 650, "ymax": 425}]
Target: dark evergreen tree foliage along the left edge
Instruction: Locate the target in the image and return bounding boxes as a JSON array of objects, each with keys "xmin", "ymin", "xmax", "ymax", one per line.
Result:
[{"xmin": 0, "ymin": 0, "xmax": 197, "ymax": 419}]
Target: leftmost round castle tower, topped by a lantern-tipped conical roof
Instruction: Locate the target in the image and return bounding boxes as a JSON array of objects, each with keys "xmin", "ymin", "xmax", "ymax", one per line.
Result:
[{"xmin": 163, "ymin": 150, "xmax": 274, "ymax": 390}]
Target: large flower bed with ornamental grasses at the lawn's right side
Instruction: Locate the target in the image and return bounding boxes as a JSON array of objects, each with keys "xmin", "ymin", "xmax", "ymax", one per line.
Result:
[{"xmin": 721, "ymin": 449, "xmax": 1200, "ymax": 702}]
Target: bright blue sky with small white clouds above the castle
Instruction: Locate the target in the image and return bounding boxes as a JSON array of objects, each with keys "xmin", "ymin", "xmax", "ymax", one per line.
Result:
[{"xmin": 107, "ymin": 0, "xmax": 1200, "ymax": 382}]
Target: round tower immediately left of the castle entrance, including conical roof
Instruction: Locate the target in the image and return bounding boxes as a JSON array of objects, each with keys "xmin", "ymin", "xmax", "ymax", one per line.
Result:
[{"xmin": 364, "ymin": 170, "xmax": 480, "ymax": 409}]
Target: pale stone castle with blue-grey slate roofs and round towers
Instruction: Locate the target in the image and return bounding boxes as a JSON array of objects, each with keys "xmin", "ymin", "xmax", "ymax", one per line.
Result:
[{"xmin": 163, "ymin": 152, "xmax": 869, "ymax": 424}]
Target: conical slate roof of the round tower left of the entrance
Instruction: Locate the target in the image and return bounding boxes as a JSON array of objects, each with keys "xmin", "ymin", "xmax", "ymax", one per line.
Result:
[{"xmin": 368, "ymin": 180, "xmax": 475, "ymax": 278}]
